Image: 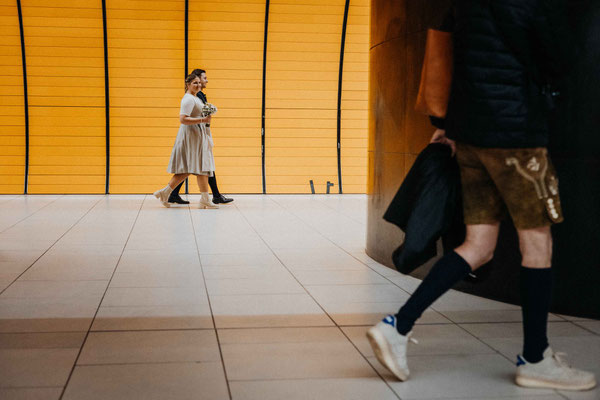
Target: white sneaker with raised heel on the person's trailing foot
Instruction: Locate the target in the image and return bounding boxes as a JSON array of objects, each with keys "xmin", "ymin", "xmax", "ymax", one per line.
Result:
[{"xmin": 367, "ymin": 315, "xmax": 418, "ymax": 381}]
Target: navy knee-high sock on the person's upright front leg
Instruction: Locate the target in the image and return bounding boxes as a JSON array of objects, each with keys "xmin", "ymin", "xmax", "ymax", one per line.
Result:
[{"xmin": 520, "ymin": 267, "xmax": 552, "ymax": 363}]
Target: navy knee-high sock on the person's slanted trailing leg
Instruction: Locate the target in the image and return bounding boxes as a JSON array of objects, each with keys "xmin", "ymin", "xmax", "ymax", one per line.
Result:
[{"xmin": 396, "ymin": 251, "xmax": 471, "ymax": 335}]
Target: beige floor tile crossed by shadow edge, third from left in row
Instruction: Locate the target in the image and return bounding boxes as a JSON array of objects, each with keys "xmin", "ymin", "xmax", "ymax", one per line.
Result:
[{"xmin": 210, "ymin": 294, "xmax": 333, "ymax": 328}]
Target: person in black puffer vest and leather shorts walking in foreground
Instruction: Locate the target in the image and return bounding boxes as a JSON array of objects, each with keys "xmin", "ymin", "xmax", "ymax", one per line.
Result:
[{"xmin": 367, "ymin": 0, "xmax": 596, "ymax": 390}]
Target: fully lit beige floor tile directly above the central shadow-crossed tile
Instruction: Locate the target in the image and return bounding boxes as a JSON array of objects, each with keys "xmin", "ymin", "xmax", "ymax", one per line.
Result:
[{"xmin": 206, "ymin": 274, "xmax": 306, "ymax": 296}]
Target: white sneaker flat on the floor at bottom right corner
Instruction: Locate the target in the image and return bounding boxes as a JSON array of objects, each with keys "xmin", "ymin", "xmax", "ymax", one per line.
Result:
[{"xmin": 515, "ymin": 347, "xmax": 596, "ymax": 390}]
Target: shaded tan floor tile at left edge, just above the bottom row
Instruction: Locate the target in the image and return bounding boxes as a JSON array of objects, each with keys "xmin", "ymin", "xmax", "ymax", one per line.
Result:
[{"xmin": 0, "ymin": 348, "xmax": 79, "ymax": 387}]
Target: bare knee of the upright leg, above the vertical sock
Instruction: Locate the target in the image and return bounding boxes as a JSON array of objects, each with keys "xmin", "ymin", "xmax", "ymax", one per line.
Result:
[{"xmin": 519, "ymin": 226, "xmax": 552, "ymax": 268}]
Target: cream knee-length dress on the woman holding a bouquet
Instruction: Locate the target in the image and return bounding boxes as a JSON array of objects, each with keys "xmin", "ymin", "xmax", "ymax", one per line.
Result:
[{"xmin": 167, "ymin": 93, "xmax": 215, "ymax": 176}]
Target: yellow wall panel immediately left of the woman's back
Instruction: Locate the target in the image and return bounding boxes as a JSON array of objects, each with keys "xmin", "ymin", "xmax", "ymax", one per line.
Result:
[{"xmin": 106, "ymin": 0, "xmax": 185, "ymax": 193}]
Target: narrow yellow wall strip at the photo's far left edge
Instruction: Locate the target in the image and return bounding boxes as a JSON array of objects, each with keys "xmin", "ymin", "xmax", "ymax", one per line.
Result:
[{"xmin": 0, "ymin": 0, "xmax": 25, "ymax": 193}]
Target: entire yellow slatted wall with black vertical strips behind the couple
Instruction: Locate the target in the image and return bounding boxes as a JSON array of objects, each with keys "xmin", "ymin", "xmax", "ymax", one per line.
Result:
[{"xmin": 0, "ymin": 0, "xmax": 369, "ymax": 193}]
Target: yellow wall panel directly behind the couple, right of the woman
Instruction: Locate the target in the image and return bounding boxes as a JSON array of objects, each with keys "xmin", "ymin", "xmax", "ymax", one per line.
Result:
[{"xmin": 188, "ymin": 0, "xmax": 265, "ymax": 193}]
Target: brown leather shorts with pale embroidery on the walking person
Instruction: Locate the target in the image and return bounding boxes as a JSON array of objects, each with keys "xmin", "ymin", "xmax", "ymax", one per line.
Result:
[{"xmin": 457, "ymin": 143, "xmax": 563, "ymax": 229}]
